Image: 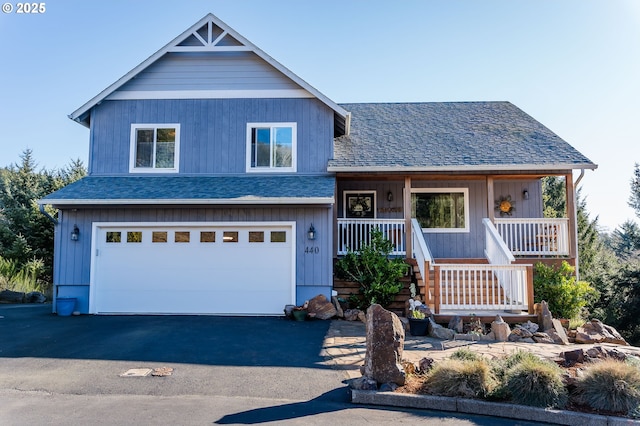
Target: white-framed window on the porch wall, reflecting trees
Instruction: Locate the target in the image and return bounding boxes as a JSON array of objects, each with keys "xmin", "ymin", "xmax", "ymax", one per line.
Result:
[{"xmin": 411, "ymin": 188, "xmax": 469, "ymax": 232}]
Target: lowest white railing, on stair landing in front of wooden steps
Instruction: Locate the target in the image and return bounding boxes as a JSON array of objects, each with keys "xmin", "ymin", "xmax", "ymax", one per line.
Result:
[{"xmin": 435, "ymin": 264, "xmax": 530, "ymax": 313}]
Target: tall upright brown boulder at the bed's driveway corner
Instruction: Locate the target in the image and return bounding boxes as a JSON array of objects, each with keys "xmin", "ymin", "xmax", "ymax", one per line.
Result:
[{"xmin": 363, "ymin": 304, "xmax": 405, "ymax": 386}]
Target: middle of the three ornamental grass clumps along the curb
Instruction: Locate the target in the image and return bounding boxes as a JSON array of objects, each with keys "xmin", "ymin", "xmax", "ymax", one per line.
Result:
[{"xmin": 503, "ymin": 356, "xmax": 568, "ymax": 407}]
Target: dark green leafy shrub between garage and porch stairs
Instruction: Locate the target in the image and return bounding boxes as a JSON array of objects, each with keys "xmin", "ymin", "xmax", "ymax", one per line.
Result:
[{"xmin": 336, "ymin": 228, "xmax": 409, "ymax": 309}]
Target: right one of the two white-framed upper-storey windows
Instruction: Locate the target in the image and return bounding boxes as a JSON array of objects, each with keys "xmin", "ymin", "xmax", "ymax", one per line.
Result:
[{"xmin": 247, "ymin": 123, "xmax": 298, "ymax": 172}]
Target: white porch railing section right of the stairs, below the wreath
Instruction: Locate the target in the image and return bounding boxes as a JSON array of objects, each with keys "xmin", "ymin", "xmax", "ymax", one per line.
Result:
[{"xmin": 495, "ymin": 218, "xmax": 569, "ymax": 256}]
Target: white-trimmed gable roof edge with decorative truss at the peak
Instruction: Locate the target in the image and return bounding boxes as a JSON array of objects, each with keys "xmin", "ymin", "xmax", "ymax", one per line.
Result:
[{"xmin": 69, "ymin": 13, "xmax": 349, "ymax": 134}]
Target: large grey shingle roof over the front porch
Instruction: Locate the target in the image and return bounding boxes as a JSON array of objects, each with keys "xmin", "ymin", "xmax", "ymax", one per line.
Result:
[{"xmin": 328, "ymin": 102, "xmax": 597, "ymax": 172}]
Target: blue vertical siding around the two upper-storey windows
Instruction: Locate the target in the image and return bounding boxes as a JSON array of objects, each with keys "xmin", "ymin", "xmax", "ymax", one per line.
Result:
[{"xmin": 89, "ymin": 99, "xmax": 333, "ymax": 176}]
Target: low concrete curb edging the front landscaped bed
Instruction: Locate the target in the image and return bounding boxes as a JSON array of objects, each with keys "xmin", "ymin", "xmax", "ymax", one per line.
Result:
[{"xmin": 351, "ymin": 389, "xmax": 640, "ymax": 426}]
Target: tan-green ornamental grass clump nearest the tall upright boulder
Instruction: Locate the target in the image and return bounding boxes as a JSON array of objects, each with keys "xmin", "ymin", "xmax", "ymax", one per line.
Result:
[{"xmin": 422, "ymin": 359, "xmax": 496, "ymax": 398}]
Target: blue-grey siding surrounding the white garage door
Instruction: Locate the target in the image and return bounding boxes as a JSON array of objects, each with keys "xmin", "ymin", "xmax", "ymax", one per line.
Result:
[{"xmin": 54, "ymin": 206, "xmax": 333, "ymax": 312}]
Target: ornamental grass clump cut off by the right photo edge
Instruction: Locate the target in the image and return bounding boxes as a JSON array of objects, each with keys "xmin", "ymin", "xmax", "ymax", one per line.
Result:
[{"xmin": 575, "ymin": 360, "xmax": 640, "ymax": 413}]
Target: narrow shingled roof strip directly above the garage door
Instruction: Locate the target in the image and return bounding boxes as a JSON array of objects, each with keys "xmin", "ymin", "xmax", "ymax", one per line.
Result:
[{"xmin": 39, "ymin": 175, "xmax": 335, "ymax": 205}]
